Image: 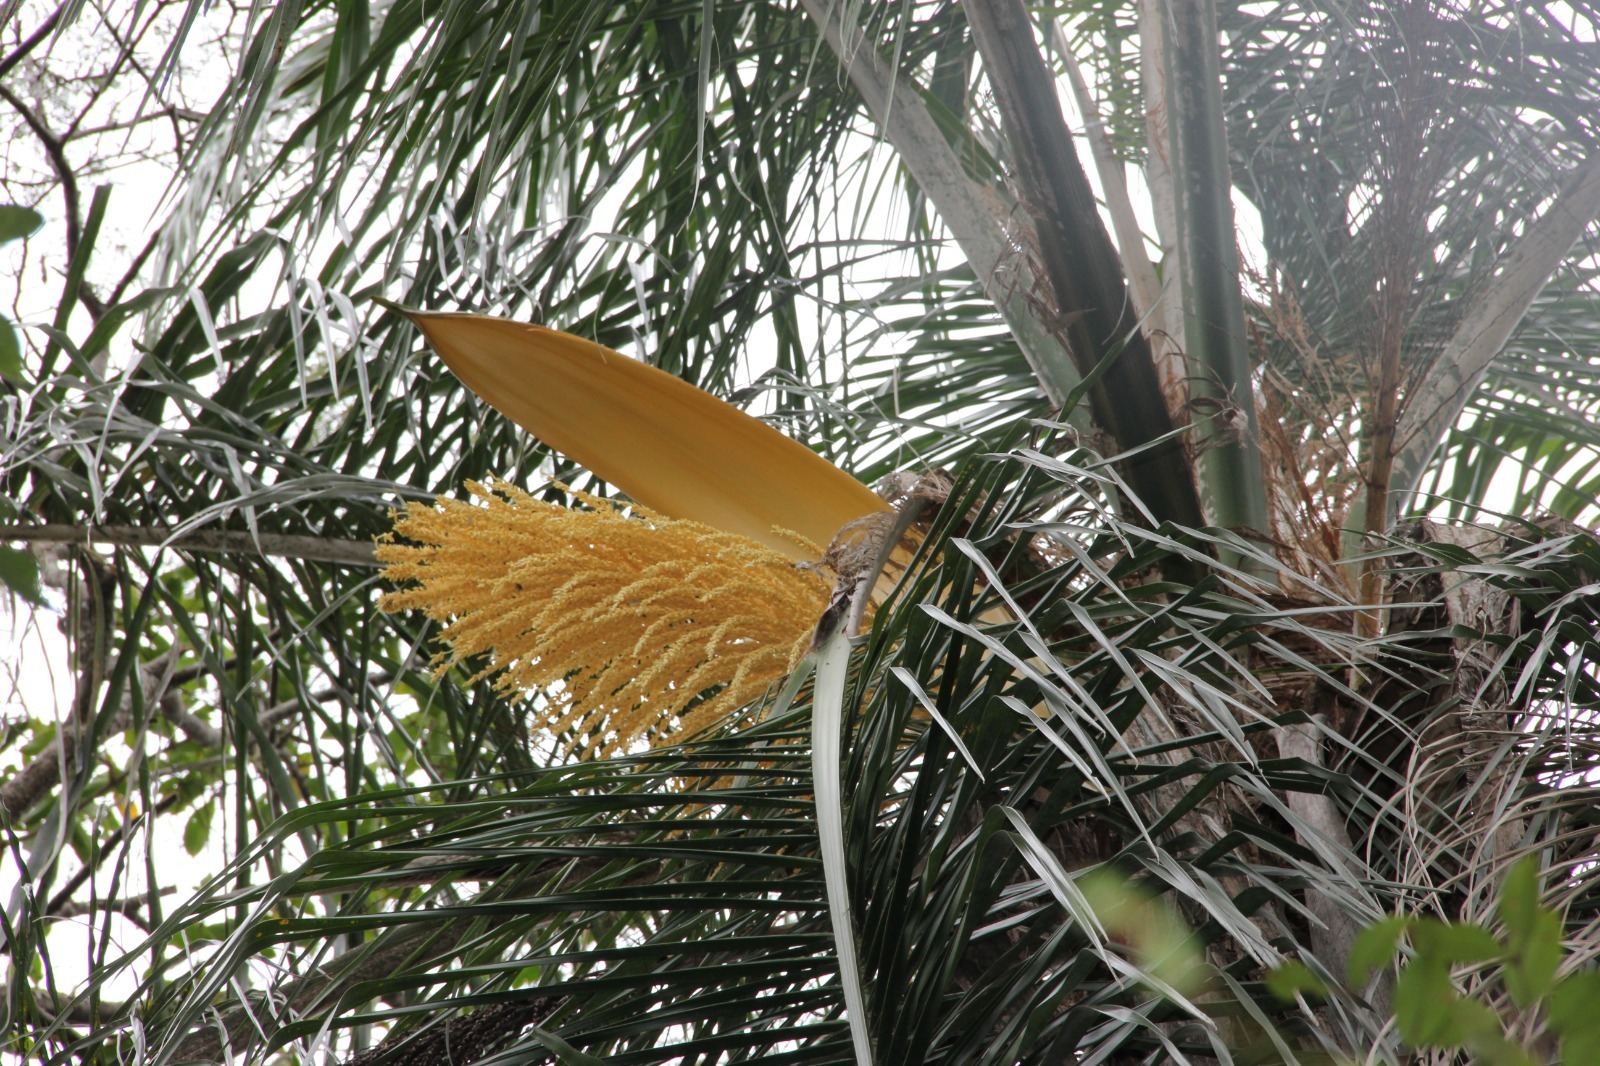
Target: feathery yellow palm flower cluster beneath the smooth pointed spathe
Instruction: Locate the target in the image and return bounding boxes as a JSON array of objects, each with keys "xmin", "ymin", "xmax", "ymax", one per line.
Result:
[{"xmin": 378, "ymin": 482, "xmax": 830, "ymax": 754}]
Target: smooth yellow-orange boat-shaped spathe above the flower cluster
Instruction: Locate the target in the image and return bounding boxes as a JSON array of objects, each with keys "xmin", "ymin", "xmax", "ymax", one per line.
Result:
[{"xmin": 390, "ymin": 311, "xmax": 888, "ymax": 560}]
